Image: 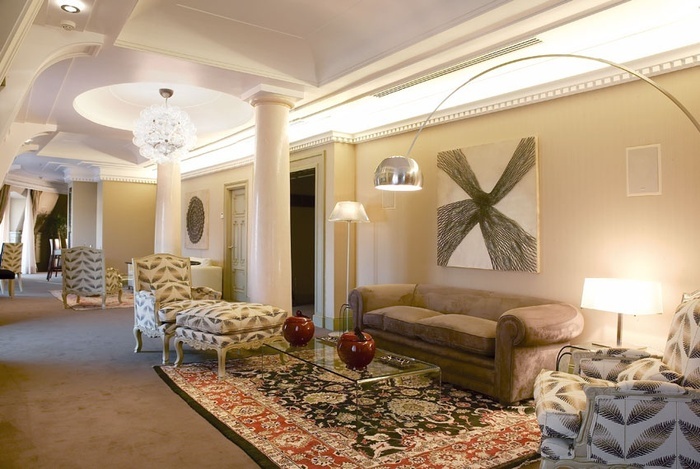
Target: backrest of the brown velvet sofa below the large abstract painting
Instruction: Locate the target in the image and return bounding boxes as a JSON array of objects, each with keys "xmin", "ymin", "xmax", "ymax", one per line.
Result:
[{"xmin": 410, "ymin": 284, "xmax": 552, "ymax": 321}]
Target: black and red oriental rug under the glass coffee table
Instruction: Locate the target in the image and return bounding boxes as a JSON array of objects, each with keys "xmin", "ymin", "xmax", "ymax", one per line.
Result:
[{"xmin": 154, "ymin": 355, "xmax": 540, "ymax": 469}]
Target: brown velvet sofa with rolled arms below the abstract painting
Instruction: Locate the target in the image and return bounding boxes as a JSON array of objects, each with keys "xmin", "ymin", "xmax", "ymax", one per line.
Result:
[{"xmin": 349, "ymin": 284, "xmax": 583, "ymax": 404}]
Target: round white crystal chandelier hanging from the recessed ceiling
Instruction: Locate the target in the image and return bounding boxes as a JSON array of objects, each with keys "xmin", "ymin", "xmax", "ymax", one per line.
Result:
[{"xmin": 133, "ymin": 88, "xmax": 197, "ymax": 164}]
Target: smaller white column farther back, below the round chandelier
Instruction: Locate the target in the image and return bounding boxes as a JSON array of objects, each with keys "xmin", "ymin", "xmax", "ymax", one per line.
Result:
[{"xmin": 154, "ymin": 161, "xmax": 182, "ymax": 256}]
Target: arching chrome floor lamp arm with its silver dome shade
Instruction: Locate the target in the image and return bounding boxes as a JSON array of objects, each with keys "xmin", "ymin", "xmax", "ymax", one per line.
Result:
[{"xmin": 374, "ymin": 54, "xmax": 700, "ymax": 191}]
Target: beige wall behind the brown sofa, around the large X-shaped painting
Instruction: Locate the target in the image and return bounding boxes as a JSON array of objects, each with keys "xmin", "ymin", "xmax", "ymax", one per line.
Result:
[{"xmin": 357, "ymin": 67, "xmax": 700, "ymax": 348}]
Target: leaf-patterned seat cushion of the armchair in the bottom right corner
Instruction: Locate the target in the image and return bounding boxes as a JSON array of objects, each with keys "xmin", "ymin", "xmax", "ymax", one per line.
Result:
[{"xmin": 534, "ymin": 370, "xmax": 615, "ymax": 439}]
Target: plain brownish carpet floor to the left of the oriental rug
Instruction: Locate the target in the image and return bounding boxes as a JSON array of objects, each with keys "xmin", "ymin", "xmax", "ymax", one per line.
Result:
[{"xmin": 0, "ymin": 273, "xmax": 536, "ymax": 469}]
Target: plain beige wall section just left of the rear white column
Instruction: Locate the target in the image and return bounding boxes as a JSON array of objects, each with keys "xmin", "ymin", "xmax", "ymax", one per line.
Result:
[{"xmin": 99, "ymin": 181, "xmax": 156, "ymax": 275}]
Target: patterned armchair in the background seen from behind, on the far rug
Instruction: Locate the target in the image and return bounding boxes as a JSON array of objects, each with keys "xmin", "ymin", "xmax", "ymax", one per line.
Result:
[{"xmin": 61, "ymin": 246, "xmax": 122, "ymax": 309}]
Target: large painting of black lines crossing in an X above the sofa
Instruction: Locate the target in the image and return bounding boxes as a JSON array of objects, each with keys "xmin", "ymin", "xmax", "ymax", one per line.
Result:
[{"xmin": 437, "ymin": 137, "xmax": 539, "ymax": 272}]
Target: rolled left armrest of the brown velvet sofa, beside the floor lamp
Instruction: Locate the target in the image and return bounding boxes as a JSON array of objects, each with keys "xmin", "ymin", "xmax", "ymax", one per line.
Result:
[{"xmin": 348, "ymin": 283, "xmax": 416, "ymax": 328}]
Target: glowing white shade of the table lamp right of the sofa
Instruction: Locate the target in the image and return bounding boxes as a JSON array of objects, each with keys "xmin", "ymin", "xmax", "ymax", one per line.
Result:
[{"xmin": 581, "ymin": 278, "xmax": 663, "ymax": 315}]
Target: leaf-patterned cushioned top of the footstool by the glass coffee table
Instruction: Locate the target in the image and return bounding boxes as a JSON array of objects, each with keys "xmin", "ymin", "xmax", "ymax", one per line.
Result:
[{"xmin": 164, "ymin": 300, "xmax": 288, "ymax": 335}]
